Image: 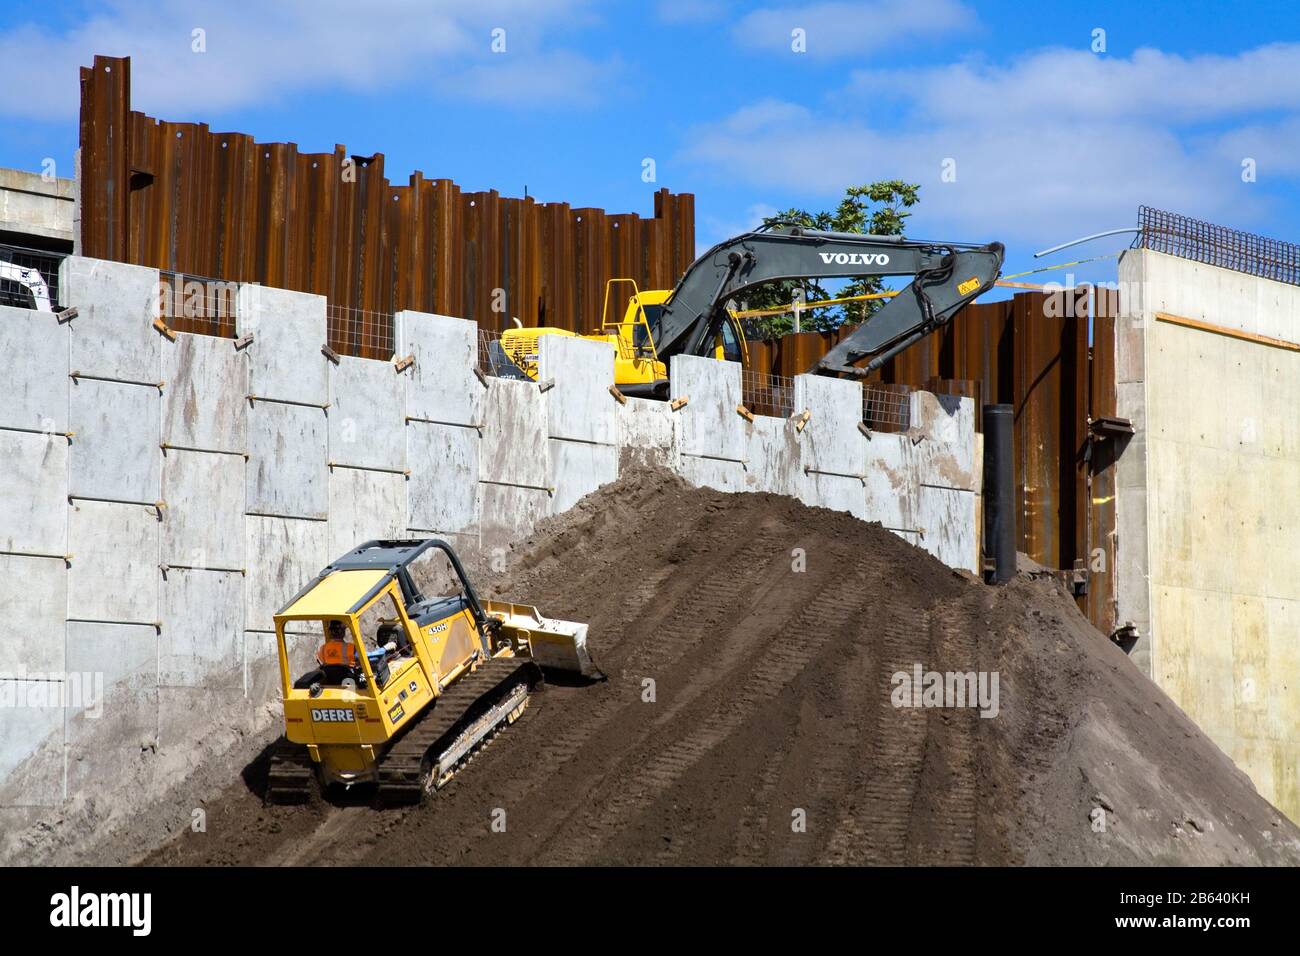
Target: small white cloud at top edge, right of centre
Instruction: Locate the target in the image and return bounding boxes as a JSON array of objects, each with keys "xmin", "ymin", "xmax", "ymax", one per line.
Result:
[{"xmin": 733, "ymin": 0, "xmax": 975, "ymax": 56}]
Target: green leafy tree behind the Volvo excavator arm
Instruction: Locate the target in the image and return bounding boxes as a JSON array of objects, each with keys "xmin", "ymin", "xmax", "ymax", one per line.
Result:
[{"xmin": 742, "ymin": 179, "xmax": 920, "ymax": 338}]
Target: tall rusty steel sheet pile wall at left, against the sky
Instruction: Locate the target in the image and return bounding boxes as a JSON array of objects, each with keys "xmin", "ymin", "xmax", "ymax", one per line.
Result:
[{"xmin": 81, "ymin": 56, "xmax": 696, "ymax": 358}]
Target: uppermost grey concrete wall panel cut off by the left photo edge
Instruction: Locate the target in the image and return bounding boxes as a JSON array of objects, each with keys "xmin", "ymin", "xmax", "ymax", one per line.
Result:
[{"xmin": 0, "ymin": 306, "xmax": 70, "ymax": 432}]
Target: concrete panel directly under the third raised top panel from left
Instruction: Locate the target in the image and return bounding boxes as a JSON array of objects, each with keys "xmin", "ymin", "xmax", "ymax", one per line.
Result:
[{"xmin": 406, "ymin": 421, "xmax": 480, "ymax": 532}]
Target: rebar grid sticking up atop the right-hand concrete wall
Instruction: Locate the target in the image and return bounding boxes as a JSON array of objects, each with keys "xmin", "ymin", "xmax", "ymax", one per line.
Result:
[{"xmin": 1135, "ymin": 206, "xmax": 1300, "ymax": 285}]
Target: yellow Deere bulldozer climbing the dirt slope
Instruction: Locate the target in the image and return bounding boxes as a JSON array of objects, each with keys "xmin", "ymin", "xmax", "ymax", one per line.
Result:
[{"xmin": 267, "ymin": 538, "xmax": 603, "ymax": 805}]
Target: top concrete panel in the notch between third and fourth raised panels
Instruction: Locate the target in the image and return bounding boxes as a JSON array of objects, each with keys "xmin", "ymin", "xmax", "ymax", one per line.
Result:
[{"xmin": 478, "ymin": 378, "xmax": 550, "ymax": 488}]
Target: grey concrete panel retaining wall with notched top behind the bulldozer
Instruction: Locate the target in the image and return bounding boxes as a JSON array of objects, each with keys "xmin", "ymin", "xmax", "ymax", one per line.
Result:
[{"xmin": 0, "ymin": 259, "xmax": 979, "ymax": 818}]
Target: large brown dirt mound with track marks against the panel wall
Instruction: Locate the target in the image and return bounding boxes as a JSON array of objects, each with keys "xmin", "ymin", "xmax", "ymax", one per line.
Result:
[{"xmin": 129, "ymin": 470, "xmax": 1300, "ymax": 865}]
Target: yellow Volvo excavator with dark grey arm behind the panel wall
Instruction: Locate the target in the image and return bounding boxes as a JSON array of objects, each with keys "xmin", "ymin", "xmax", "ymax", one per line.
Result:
[{"xmin": 489, "ymin": 224, "xmax": 1004, "ymax": 398}]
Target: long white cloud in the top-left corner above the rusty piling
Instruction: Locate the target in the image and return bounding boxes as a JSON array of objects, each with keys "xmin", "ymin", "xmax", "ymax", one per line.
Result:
[{"xmin": 0, "ymin": 0, "xmax": 612, "ymax": 120}]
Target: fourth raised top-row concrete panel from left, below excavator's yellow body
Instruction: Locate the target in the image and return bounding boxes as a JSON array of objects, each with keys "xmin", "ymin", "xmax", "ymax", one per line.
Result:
[{"xmin": 537, "ymin": 336, "xmax": 618, "ymax": 445}]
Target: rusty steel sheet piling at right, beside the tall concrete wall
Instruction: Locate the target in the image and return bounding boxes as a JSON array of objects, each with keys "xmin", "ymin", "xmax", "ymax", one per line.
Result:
[{"xmin": 749, "ymin": 289, "xmax": 1119, "ymax": 633}]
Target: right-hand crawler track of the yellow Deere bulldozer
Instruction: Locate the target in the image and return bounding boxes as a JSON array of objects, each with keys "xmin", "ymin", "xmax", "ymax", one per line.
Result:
[{"xmin": 378, "ymin": 657, "xmax": 542, "ymax": 806}]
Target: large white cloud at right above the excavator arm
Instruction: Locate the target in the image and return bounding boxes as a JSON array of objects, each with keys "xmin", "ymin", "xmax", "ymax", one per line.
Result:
[{"xmin": 686, "ymin": 46, "xmax": 1300, "ymax": 245}]
